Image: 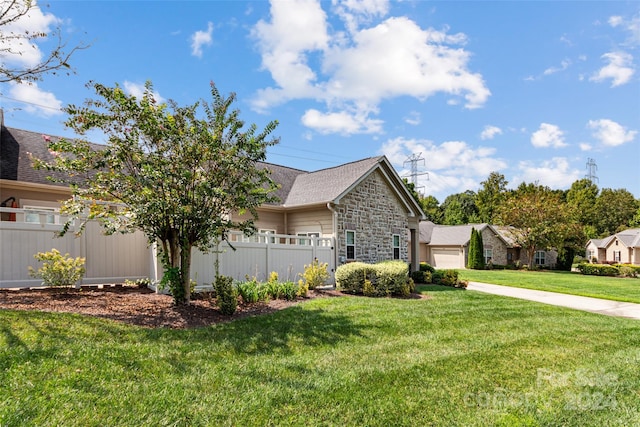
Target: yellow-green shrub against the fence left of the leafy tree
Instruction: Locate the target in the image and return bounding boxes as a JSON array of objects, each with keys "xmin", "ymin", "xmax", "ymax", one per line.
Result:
[{"xmin": 29, "ymin": 249, "xmax": 85, "ymax": 287}]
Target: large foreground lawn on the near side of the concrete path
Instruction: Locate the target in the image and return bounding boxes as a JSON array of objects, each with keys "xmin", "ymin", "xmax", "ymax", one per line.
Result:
[{"xmin": 0, "ymin": 286, "xmax": 640, "ymax": 427}]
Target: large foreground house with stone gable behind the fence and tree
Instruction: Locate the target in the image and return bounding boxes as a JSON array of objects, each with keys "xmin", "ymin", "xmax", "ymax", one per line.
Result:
[{"xmin": 0, "ymin": 118, "xmax": 424, "ymax": 273}]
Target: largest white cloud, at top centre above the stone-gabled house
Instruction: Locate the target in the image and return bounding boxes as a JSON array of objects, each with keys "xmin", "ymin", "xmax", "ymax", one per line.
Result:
[{"xmin": 252, "ymin": 0, "xmax": 491, "ymax": 135}]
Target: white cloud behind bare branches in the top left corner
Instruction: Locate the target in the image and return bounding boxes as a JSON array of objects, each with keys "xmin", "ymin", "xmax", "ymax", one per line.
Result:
[{"xmin": 0, "ymin": 2, "xmax": 61, "ymax": 67}]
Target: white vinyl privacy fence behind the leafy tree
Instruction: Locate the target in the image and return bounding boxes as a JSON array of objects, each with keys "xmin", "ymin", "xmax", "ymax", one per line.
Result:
[{"xmin": 0, "ymin": 208, "xmax": 335, "ymax": 288}]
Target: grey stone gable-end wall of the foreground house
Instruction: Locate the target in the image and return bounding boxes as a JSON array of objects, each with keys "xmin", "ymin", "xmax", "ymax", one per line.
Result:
[{"xmin": 335, "ymin": 171, "xmax": 409, "ymax": 263}]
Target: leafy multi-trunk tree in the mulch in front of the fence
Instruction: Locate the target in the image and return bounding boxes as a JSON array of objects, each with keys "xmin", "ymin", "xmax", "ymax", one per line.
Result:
[{"xmin": 35, "ymin": 83, "xmax": 278, "ymax": 303}]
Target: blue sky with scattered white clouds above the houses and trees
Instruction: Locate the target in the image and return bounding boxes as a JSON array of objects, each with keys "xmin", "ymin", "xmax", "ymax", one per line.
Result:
[{"xmin": 0, "ymin": 0, "xmax": 640, "ymax": 202}]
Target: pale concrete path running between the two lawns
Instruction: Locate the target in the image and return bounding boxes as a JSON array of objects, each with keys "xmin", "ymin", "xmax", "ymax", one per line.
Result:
[{"xmin": 467, "ymin": 282, "xmax": 640, "ymax": 320}]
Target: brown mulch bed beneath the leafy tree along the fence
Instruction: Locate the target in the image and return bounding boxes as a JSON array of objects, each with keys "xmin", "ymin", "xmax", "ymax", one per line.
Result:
[{"xmin": 0, "ymin": 286, "xmax": 341, "ymax": 329}]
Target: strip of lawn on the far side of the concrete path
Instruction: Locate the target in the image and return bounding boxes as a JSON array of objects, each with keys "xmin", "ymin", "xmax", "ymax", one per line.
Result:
[{"xmin": 460, "ymin": 270, "xmax": 640, "ymax": 303}]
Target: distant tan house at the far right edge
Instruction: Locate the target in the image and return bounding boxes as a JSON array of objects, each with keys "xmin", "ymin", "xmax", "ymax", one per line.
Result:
[{"xmin": 586, "ymin": 228, "xmax": 640, "ymax": 265}]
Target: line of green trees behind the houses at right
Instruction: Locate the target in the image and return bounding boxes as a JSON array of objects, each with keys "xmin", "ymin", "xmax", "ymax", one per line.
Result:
[{"xmin": 407, "ymin": 172, "xmax": 640, "ymax": 266}]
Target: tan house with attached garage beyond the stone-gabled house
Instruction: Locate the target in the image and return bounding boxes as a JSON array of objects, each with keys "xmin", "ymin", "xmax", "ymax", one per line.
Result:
[{"xmin": 420, "ymin": 221, "xmax": 557, "ymax": 268}]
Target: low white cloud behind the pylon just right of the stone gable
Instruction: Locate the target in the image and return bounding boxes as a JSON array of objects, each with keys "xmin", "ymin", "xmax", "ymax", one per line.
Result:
[{"xmin": 380, "ymin": 138, "xmax": 507, "ymax": 201}]
